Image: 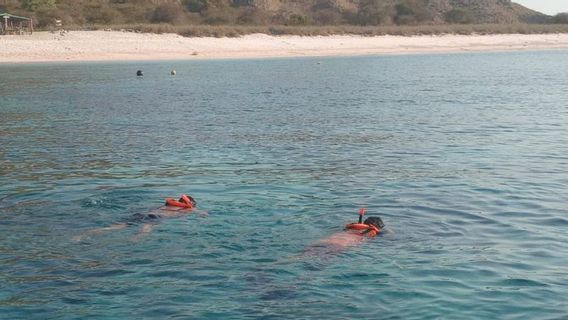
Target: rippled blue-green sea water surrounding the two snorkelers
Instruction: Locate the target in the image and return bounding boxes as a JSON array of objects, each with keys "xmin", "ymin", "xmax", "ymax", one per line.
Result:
[{"xmin": 0, "ymin": 51, "xmax": 568, "ymax": 319}]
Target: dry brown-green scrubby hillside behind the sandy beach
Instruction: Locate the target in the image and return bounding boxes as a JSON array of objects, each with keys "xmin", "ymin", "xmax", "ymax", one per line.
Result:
[{"xmin": 0, "ymin": 0, "xmax": 566, "ymax": 31}]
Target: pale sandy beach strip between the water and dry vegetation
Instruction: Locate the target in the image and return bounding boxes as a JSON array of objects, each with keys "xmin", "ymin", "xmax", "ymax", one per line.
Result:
[{"xmin": 0, "ymin": 31, "xmax": 568, "ymax": 63}]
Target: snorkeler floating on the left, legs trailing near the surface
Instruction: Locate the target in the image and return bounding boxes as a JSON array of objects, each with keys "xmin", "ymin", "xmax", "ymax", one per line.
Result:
[{"xmin": 73, "ymin": 194, "xmax": 207, "ymax": 241}]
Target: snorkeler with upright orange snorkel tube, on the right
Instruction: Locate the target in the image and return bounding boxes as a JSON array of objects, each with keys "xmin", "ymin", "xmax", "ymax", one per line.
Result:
[{"xmin": 302, "ymin": 208, "xmax": 385, "ymax": 256}]
